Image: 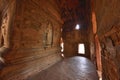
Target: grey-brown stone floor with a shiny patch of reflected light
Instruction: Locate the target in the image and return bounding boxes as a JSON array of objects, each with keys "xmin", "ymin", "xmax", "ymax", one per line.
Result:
[{"xmin": 27, "ymin": 56, "xmax": 99, "ymax": 80}]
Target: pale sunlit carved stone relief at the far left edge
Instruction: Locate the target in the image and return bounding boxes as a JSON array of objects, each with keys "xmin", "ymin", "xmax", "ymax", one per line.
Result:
[{"xmin": 0, "ymin": 14, "xmax": 9, "ymax": 62}]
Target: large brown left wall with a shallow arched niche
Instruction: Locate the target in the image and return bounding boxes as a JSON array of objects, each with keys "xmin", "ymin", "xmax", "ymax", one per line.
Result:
[{"xmin": 0, "ymin": 0, "xmax": 62, "ymax": 80}]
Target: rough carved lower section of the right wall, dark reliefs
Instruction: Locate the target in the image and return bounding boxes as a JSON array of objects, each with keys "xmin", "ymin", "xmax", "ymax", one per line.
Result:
[{"xmin": 101, "ymin": 26, "xmax": 120, "ymax": 80}]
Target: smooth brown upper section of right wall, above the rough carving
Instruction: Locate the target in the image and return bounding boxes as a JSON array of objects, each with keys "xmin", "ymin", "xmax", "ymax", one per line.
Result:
[{"xmin": 95, "ymin": 0, "xmax": 120, "ymax": 35}]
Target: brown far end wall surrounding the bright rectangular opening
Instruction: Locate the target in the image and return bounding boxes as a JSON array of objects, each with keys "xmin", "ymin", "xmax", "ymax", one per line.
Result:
[{"xmin": 63, "ymin": 29, "xmax": 90, "ymax": 58}]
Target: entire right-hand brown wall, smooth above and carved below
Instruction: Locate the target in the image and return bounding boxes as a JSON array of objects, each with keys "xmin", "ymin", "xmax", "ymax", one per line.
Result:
[{"xmin": 95, "ymin": 0, "xmax": 120, "ymax": 80}]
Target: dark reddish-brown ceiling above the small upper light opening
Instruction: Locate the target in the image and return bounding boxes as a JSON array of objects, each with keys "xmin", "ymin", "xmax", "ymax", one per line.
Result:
[{"xmin": 59, "ymin": 0, "xmax": 91, "ymax": 31}]
